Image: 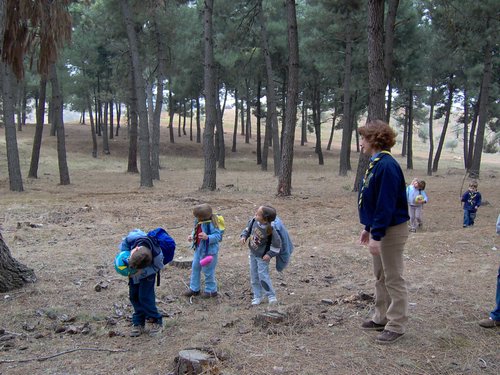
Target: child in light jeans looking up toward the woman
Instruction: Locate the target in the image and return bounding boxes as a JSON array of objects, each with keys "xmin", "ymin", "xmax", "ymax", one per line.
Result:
[{"xmin": 240, "ymin": 206, "xmax": 281, "ymax": 306}]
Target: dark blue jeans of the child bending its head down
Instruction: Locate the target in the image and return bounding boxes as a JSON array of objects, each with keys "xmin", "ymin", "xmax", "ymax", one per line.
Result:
[{"xmin": 128, "ymin": 274, "xmax": 162, "ymax": 326}]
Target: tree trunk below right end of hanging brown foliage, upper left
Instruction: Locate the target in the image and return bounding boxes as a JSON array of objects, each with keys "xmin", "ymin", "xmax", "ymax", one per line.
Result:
[{"xmin": 49, "ymin": 63, "xmax": 70, "ymax": 185}]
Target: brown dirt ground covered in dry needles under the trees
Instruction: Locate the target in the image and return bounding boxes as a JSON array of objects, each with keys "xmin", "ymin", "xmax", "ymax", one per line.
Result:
[{"xmin": 0, "ymin": 124, "xmax": 500, "ymax": 375}]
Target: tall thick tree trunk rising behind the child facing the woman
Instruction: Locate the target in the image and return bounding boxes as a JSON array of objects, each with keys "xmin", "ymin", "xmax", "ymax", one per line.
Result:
[{"xmin": 275, "ymin": 0, "xmax": 299, "ymax": 196}]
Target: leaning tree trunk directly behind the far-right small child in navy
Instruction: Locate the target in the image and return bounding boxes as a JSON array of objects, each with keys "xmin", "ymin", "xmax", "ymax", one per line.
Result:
[{"xmin": 469, "ymin": 43, "xmax": 493, "ymax": 178}]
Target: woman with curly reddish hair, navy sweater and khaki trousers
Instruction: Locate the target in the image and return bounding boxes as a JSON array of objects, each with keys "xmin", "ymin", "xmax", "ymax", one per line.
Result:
[{"xmin": 358, "ymin": 120, "xmax": 409, "ymax": 344}]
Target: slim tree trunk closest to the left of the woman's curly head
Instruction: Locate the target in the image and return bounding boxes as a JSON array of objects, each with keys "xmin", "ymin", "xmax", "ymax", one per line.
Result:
[{"xmin": 339, "ymin": 28, "xmax": 352, "ymax": 176}]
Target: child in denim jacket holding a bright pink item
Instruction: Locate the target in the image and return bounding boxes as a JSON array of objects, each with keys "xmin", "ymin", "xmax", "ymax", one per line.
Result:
[{"xmin": 184, "ymin": 203, "xmax": 224, "ymax": 298}]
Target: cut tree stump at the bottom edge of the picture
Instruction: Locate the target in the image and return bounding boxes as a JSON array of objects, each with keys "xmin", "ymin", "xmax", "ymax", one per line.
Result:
[{"xmin": 174, "ymin": 349, "xmax": 220, "ymax": 375}]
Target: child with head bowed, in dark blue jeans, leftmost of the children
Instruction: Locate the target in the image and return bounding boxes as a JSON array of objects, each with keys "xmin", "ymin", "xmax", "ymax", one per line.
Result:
[{"xmin": 122, "ymin": 235, "xmax": 163, "ymax": 337}]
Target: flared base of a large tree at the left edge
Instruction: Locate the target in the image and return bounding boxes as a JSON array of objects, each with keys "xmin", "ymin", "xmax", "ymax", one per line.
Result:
[{"xmin": 0, "ymin": 233, "xmax": 36, "ymax": 293}]
